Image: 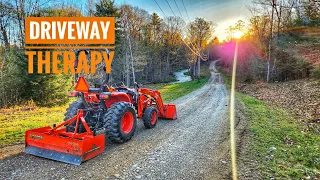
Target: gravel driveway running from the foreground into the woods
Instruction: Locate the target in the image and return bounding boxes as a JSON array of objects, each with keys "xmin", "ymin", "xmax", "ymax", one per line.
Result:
[{"xmin": 0, "ymin": 61, "xmax": 230, "ymax": 179}]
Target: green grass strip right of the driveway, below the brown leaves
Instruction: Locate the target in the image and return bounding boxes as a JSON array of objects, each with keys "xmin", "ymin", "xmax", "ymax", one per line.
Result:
[{"xmin": 237, "ymin": 94, "xmax": 320, "ymax": 179}]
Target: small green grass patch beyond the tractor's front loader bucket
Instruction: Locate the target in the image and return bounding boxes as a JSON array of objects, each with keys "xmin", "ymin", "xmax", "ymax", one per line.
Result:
[{"xmin": 148, "ymin": 77, "xmax": 209, "ymax": 102}]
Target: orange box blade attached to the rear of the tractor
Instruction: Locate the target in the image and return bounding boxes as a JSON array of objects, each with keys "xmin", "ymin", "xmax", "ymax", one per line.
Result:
[{"xmin": 24, "ymin": 111, "xmax": 105, "ymax": 165}]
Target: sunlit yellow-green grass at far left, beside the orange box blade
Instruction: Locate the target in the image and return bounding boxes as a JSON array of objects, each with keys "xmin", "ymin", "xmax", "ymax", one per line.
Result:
[{"xmin": 0, "ymin": 105, "xmax": 68, "ymax": 147}]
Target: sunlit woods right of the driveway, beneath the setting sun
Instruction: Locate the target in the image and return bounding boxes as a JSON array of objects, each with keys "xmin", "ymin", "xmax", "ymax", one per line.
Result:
[{"xmin": 213, "ymin": 0, "xmax": 320, "ymax": 82}]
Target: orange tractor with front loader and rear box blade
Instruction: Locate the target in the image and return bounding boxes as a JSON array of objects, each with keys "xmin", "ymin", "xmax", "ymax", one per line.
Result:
[{"xmin": 25, "ymin": 50, "xmax": 177, "ymax": 165}]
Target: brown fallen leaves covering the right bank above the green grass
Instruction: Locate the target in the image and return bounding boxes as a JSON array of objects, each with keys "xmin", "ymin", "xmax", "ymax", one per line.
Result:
[{"xmin": 239, "ymin": 79, "xmax": 320, "ymax": 134}]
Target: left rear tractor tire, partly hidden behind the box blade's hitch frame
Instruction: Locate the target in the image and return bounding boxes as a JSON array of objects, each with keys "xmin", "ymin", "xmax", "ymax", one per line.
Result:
[{"xmin": 64, "ymin": 99, "xmax": 86, "ymax": 133}]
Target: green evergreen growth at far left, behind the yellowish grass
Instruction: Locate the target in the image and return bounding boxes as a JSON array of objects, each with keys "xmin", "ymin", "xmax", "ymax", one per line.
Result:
[{"xmin": 0, "ymin": 50, "xmax": 72, "ymax": 107}]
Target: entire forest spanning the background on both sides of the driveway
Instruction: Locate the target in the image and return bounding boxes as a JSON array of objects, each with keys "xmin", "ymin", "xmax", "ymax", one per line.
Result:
[{"xmin": 0, "ymin": 0, "xmax": 320, "ymax": 107}]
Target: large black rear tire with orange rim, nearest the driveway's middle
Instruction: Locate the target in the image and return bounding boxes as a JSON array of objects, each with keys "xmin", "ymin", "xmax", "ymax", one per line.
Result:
[{"xmin": 103, "ymin": 102, "xmax": 137, "ymax": 143}]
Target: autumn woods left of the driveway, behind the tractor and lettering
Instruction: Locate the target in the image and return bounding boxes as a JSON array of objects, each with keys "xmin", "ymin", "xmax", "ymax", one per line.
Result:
[{"xmin": 0, "ymin": 0, "xmax": 213, "ymax": 107}]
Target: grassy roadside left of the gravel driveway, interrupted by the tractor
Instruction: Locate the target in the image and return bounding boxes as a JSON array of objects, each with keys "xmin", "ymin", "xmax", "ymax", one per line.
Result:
[{"xmin": 0, "ymin": 71, "xmax": 209, "ymax": 147}]
